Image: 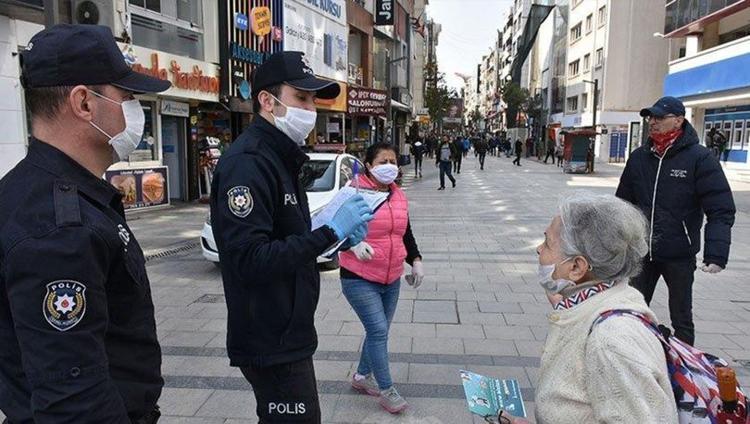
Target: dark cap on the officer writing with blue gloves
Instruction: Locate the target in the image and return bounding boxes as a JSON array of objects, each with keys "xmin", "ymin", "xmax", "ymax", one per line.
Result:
[{"xmin": 253, "ymin": 51, "xmax": 341, "ymax": 99}]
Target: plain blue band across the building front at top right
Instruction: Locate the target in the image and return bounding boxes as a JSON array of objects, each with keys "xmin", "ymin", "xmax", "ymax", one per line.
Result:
[{"xmin": 664, "ymin": 53, "xmax": 750, "ymax": 98}]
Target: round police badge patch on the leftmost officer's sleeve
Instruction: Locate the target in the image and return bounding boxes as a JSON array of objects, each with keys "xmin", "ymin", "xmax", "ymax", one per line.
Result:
[{"xmin": 42, "ymin": 280, "xmax": 86, "ymax": 331}]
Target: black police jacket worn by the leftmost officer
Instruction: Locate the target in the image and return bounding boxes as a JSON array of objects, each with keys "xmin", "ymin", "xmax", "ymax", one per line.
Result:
[{"xmin": 0, "ymin": 140, "xmax": 163, "ymax": 424}]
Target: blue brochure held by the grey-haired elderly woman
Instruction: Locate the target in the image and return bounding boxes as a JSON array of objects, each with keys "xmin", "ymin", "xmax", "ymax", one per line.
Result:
[{"xmin": 459, "ymin": 370, "xmax": 526, "ymax": 418}]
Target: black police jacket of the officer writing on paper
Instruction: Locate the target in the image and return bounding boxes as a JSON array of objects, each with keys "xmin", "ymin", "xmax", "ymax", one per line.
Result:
[{"xmin": 211, "ymin": 116, "xmax": 337, "ymax": 367}]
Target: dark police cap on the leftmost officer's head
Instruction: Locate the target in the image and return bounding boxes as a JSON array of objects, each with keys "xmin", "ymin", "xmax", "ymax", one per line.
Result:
[{"xmin": 21, "ymin": 24, "xmax": 172, "ymax": 93}]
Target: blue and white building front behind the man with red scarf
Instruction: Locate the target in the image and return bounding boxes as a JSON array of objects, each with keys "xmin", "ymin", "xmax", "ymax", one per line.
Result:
[{"xmin": 664, "ymin": 0, "xmax": 750, "ymax": 169}]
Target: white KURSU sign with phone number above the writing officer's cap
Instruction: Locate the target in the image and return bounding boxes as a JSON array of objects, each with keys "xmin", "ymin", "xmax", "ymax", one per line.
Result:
[{"xmin": 284, "ymin": 0, "xmax": 349, "ymax": 82}]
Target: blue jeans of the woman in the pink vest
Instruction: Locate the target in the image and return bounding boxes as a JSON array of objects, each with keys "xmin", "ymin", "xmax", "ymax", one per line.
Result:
[{"xmin": 341, "ymin": 278, "xmax": 401, "ymax": 390}]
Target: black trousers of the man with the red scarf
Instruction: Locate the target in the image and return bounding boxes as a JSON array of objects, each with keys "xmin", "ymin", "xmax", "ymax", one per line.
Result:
[{"xmin": 630, "ymin": 259, "xmax": 696, "ymax": 346}]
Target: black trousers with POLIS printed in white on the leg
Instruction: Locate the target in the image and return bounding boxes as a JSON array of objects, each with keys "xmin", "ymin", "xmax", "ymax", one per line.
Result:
[{"xmin": 240, "ymin": 357, "xmax": 320, "ymax": 424}]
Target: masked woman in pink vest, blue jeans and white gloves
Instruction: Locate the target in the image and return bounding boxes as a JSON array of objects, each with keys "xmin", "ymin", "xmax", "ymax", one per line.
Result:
[{"xmin": 340, "ymin": 144, "xmax": 424, "ymax": 414}]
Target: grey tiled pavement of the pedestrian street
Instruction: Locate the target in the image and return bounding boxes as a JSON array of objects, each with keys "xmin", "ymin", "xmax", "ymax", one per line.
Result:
[{"xmin": 2, "ymin": 155, "xmax": 750, "ymax": 424}]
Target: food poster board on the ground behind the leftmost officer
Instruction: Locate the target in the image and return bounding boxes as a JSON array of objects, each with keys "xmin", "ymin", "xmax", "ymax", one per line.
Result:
[{"xmin": 105, "ymin": 166, "xmax": 169, "ymax": 210}]
